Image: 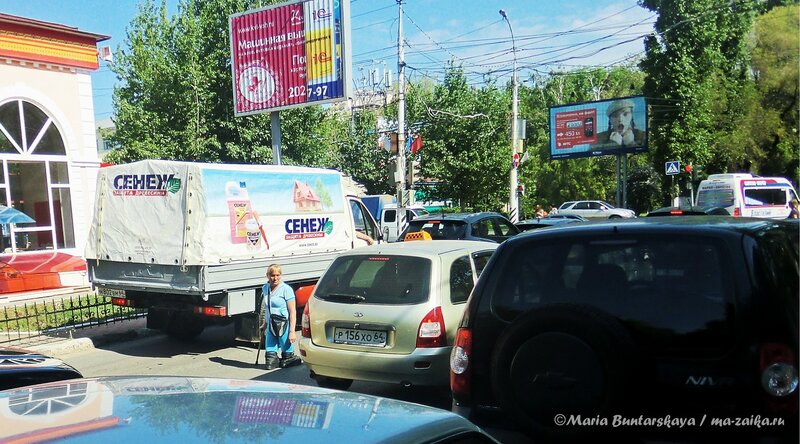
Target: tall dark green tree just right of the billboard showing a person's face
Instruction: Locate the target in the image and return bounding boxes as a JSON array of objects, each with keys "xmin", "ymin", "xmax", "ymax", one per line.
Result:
[{"xmin": 640, "ymin": 0, "xmax": 756, "ymax": 201}]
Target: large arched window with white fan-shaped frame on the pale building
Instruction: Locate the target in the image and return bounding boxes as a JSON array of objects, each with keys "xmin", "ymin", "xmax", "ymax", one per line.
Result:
[{"xmin": 0, "ymin": 99, "xmax": 75, "ymax": 253}]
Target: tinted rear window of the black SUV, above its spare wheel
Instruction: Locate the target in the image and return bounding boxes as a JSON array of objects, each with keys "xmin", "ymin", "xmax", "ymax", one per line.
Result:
[{"xmin": 487, "ymin": 236, "xmax": 732, "ymax": 348}]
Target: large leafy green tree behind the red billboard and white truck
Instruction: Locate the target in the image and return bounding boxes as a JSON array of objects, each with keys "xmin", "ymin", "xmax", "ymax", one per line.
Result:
[{"xmin": 105, "ymin": 0, "xmax": 342, "ymax": 167}]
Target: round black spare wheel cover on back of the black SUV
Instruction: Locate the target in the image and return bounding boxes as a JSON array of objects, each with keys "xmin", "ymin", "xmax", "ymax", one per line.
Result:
[{"xmin": 491, "ymin": 304, "xmax": 638, "ymax": 437}]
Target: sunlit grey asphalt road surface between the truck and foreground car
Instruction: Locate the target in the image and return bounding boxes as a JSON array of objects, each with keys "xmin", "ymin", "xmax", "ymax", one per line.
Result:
[{"xmin": 56, "ymin": 326, "xmax": 531, "ymax": 443}]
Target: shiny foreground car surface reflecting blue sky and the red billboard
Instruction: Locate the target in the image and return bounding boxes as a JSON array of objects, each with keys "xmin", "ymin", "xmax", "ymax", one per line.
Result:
[{"xmin": 0, "ymin": 377, "xmax": 494, "ymax": 444}]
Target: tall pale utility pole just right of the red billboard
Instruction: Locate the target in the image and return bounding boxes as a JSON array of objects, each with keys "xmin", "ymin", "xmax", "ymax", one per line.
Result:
[{"xmin": 394, "ymin": 0, "xmax": 406, "ymax": 239}]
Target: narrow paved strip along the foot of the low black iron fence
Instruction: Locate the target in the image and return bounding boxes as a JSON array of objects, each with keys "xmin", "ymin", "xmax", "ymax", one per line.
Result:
[{"xmin": 2, "ymin": 318, "xmax": 162, "ymax": 357}]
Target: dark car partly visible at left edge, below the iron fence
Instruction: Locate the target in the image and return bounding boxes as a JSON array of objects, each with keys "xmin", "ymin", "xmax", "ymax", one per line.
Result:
[{"xmin": 0, "ymin": 347, "xmax": 83, "ymax": 390}]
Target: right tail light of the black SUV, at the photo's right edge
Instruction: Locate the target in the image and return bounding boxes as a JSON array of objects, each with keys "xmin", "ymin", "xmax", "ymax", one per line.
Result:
[{"xmin": 759, "ymin": 344, "xmax": 798, "ymax": 414}]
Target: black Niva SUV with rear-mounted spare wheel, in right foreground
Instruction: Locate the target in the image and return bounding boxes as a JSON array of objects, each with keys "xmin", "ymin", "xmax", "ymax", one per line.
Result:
[{"xmin": 450, "ymin": 216, "xmax": 799, "ymax": 443}]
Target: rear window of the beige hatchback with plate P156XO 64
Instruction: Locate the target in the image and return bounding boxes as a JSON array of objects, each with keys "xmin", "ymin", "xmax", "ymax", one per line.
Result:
[{"xmin": 314, "ymin": 255, "xmax": 431, "ymax": 305}]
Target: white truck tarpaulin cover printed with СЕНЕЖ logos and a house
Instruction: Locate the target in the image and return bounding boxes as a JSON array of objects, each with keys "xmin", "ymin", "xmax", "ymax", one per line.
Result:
[{"xmin": 86, "ymin": 160, "xmax": 352, "ymax": 265}]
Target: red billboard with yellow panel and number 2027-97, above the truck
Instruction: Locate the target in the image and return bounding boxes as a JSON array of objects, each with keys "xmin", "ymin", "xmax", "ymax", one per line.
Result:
[{"xmin": 230, "ymin": 0, "xmax": 351, "ymax": 116}]
